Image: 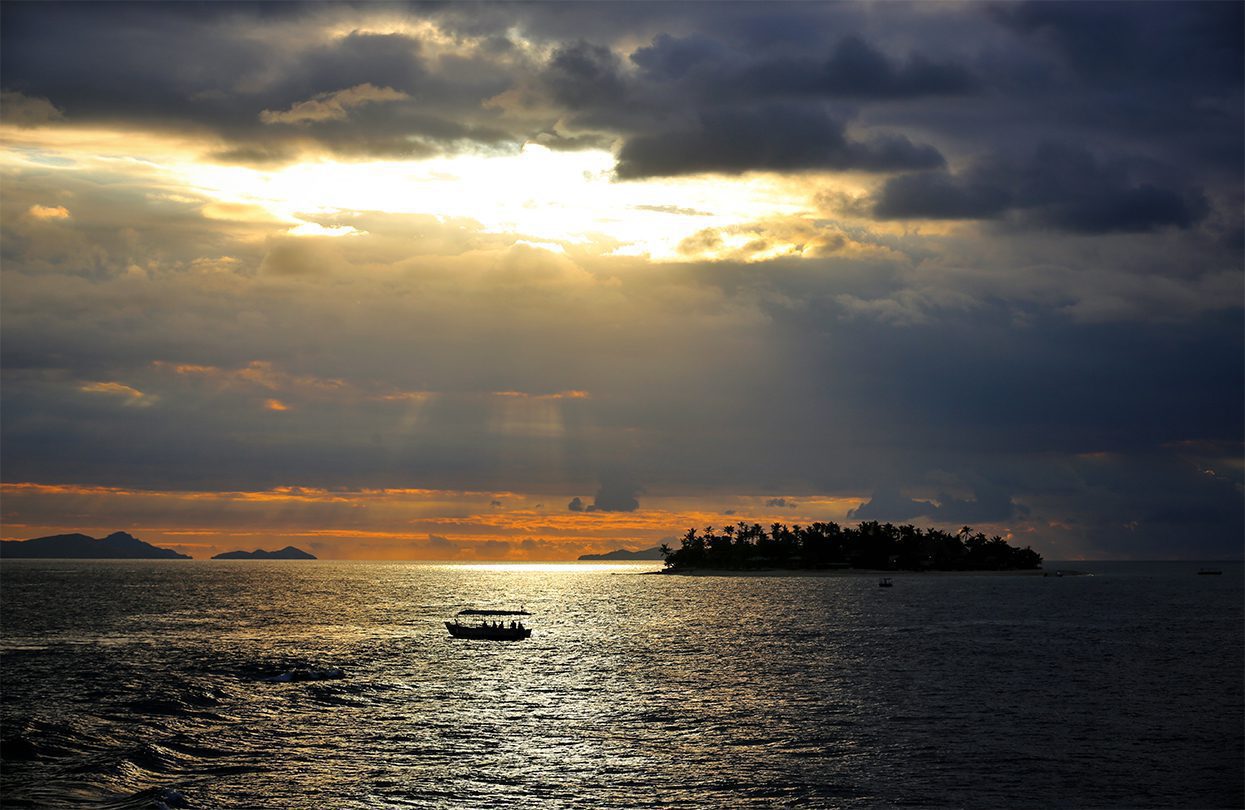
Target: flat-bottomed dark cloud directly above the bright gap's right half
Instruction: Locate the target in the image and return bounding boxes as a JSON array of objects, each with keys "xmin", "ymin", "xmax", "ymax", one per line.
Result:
[{"xmin": 618, "ymin": 105, "xmax": 944, "ymax": 179}]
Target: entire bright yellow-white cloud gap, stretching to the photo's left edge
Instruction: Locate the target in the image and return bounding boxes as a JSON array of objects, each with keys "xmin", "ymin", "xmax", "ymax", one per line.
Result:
[{"xmin": 0, "ymin": 127, "xmax": 846, "ymax": 261}]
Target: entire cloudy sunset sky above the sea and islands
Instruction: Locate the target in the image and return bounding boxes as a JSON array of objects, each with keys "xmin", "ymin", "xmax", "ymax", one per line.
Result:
[{"xmin": 0, "ymin": 1, "xmax": 1245, "ymax": 561}]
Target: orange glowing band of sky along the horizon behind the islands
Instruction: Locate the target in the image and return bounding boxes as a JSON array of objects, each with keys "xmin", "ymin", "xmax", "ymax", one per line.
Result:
[{"xmin": 0, "ymin": 482, "xmax": 860, "ymax": 561}]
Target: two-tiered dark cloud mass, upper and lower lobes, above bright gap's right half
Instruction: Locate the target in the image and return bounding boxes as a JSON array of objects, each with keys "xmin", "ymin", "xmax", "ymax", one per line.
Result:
[{"xmin": 544, "ymin": 27, "xmax": 976, "ymax": 179}]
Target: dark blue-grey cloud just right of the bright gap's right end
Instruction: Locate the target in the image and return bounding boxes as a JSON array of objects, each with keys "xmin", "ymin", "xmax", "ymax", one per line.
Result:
[{"xmin": 874, "ymin": 143, "xmax": 1209, "ymax": 234}]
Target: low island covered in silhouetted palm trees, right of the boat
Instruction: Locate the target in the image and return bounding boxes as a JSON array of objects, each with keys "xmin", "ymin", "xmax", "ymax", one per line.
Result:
[{"xmin": 660, "ymin": 520, "xmax": 1042, "ymax": 574}]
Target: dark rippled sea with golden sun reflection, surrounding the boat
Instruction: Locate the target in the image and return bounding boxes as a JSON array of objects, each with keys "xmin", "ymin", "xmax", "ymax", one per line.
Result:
[{"xmin": 0, "ymin": 560, "xmax": 1245, "ymax": 808}]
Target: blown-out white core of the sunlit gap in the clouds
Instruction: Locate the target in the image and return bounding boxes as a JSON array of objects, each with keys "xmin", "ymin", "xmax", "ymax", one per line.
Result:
[{"xmin": 174, "ymin": 144, "xmax": 807, "ymax": 259}]
